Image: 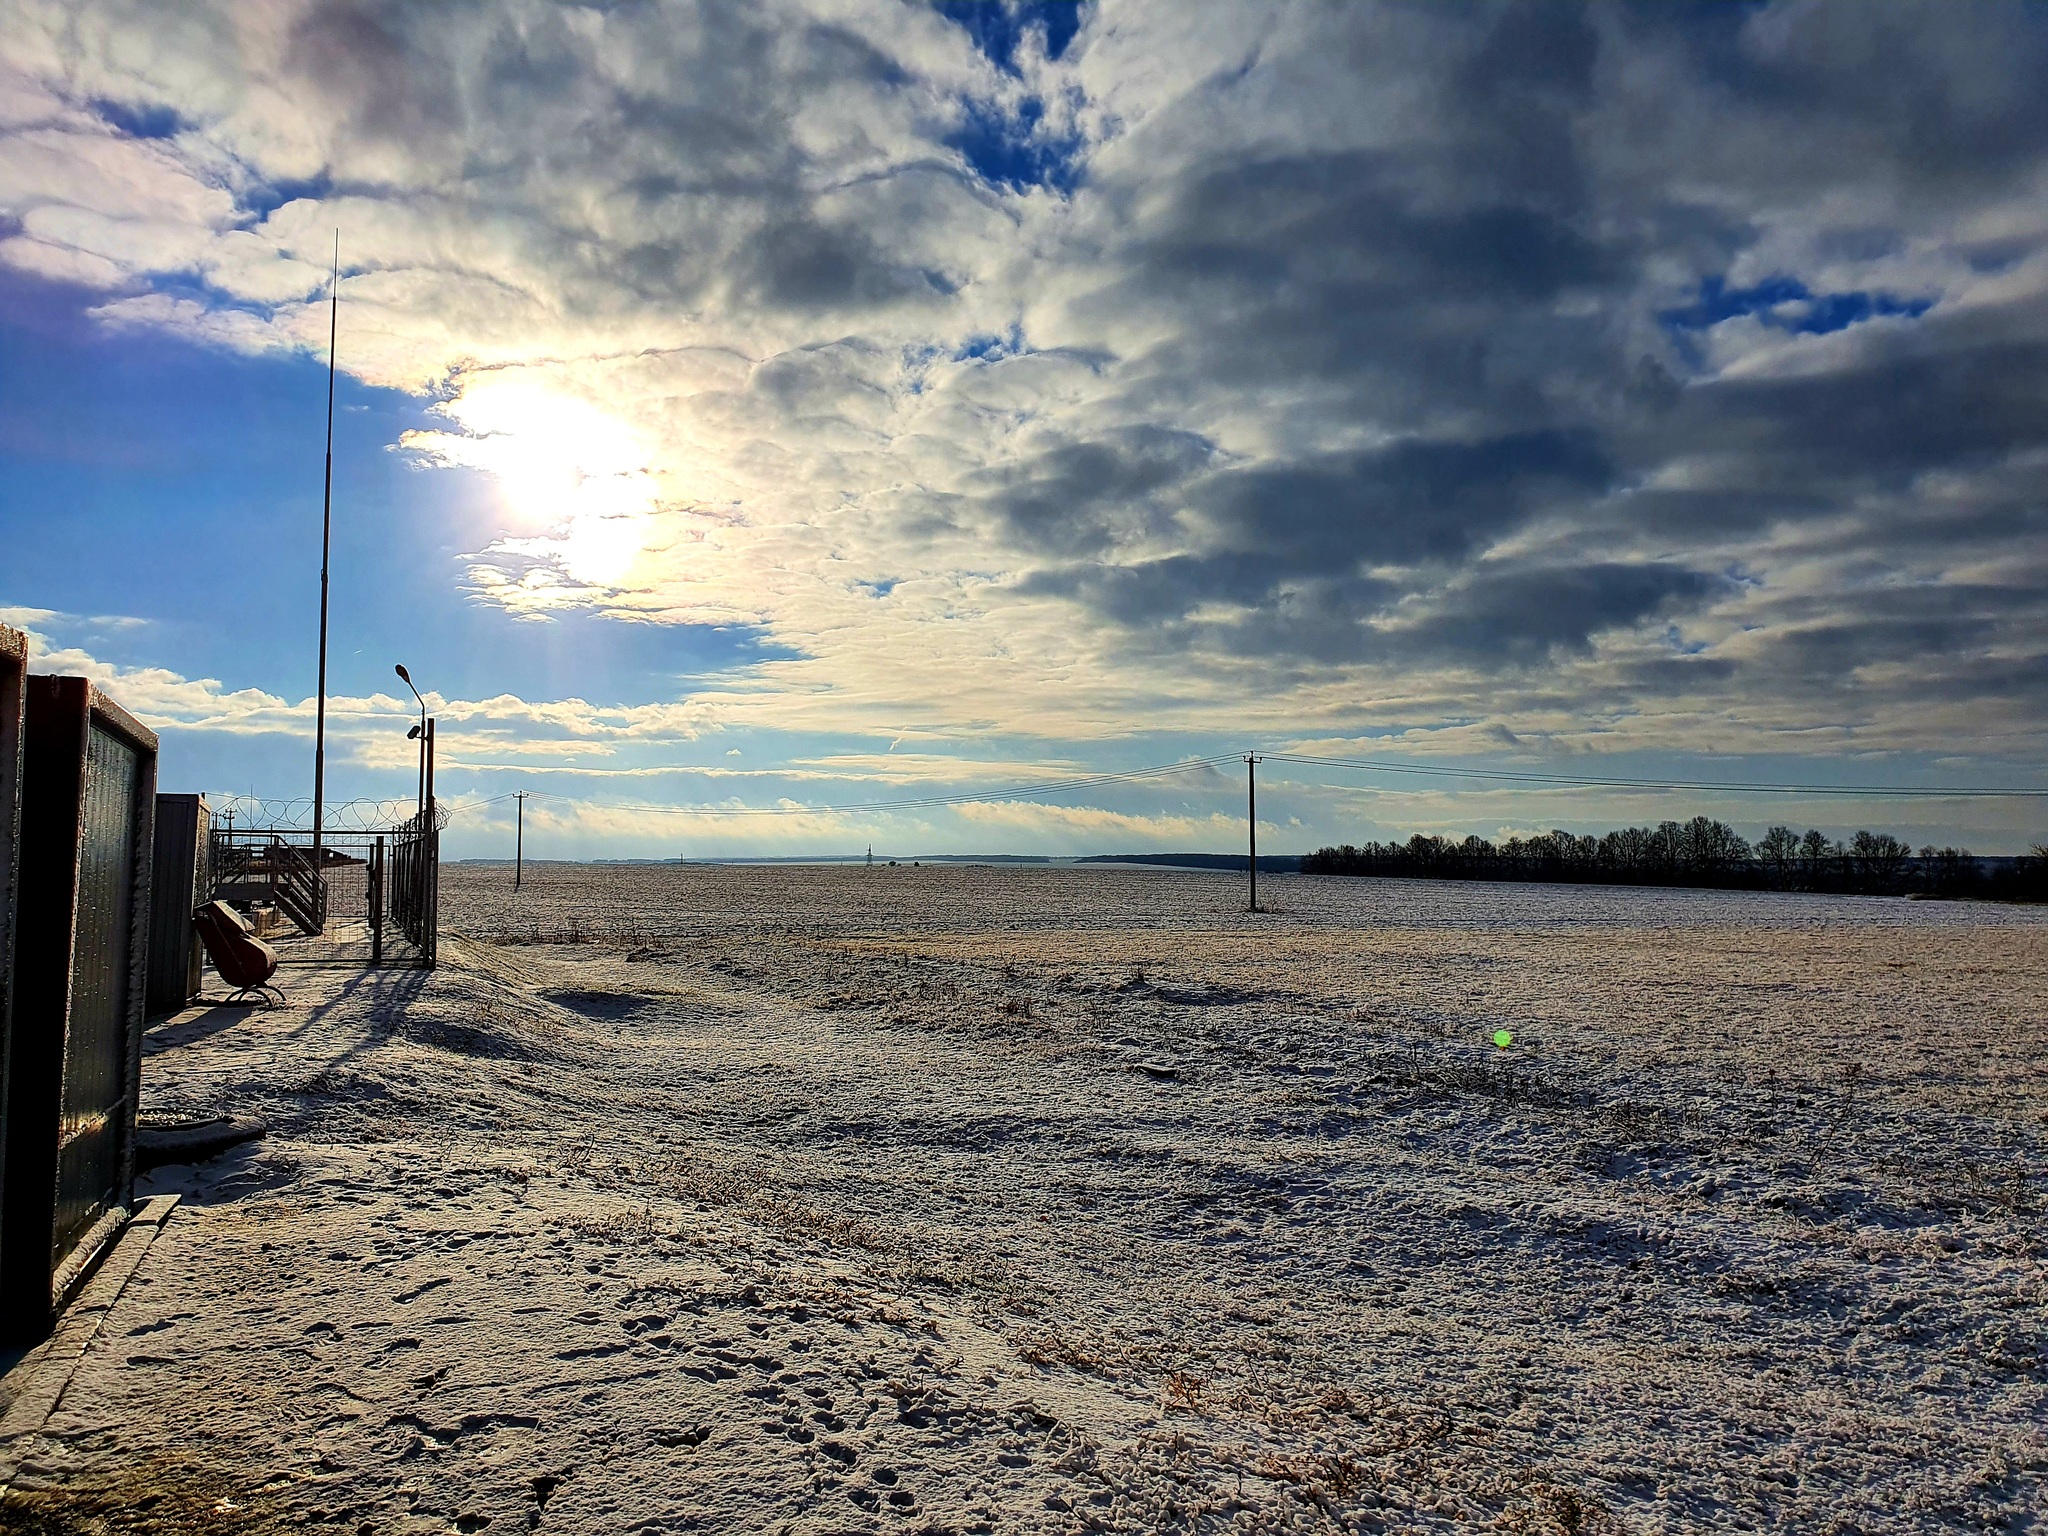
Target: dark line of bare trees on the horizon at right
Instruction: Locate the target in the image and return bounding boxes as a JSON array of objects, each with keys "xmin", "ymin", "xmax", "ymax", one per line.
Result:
[{"xmin": 1300, "ymin": 815, "xmax": 2048, "ymax": 901}]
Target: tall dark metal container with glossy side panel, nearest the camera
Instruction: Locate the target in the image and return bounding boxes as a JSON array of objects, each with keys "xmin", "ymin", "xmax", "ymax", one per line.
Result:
[{"xmin": 0, "ymin": 678, "xmax": 156, "ymax": 1341}]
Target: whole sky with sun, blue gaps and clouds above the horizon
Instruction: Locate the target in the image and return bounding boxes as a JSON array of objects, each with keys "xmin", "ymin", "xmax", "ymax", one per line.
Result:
[{"xmin": 0, "ymin": 0, "xmax": 2048, "ymax": 858}]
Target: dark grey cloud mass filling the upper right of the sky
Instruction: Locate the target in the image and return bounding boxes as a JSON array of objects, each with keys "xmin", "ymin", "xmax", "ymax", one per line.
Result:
[{"xmin": 970, "ymin": 4, "xmax": 2048, "ymax": 745}]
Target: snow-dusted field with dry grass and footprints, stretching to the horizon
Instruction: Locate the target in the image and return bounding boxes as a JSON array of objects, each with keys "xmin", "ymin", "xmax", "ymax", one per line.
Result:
[{"xmin": 4, "ymin": 866, "xmax": 2048, "ymax": 1532}]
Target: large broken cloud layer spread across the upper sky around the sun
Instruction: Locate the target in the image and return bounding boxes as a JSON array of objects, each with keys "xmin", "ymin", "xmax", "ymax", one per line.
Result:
[{"xmin": 0, "ymin": 0, "xmax": 2048, "ymax": 762}]
